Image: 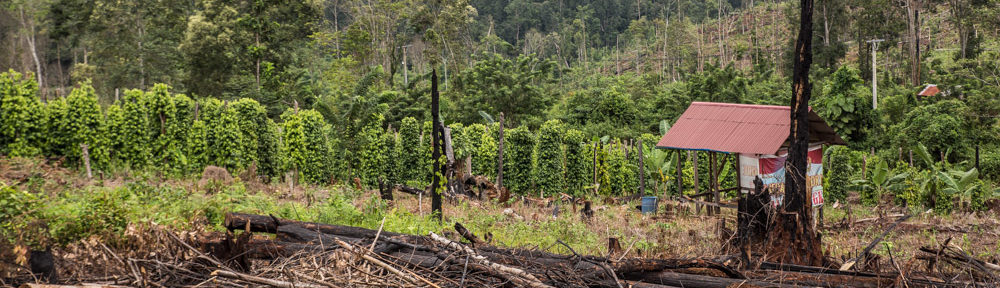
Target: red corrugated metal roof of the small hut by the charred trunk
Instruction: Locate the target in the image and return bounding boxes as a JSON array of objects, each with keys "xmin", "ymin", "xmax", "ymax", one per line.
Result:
[{"xmin": 656, "ymin": 102, "xmax": 845, "ymax": 154}]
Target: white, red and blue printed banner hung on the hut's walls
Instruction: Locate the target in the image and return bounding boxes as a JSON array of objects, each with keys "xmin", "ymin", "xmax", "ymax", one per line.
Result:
[{"xmin": 740, "ymin": 145, "xmax": 823, "ymax": 206}]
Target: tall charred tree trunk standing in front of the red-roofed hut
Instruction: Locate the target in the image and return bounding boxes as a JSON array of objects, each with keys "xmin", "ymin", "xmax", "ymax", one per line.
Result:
[{"xmin": 769, "ymin": 0, "xmax": 823, "ymax": 266}]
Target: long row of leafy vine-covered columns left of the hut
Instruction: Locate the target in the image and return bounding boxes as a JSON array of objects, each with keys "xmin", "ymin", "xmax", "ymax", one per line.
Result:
[{"xmin": 0, "ymin": 72, "xmax": 691, "ymax": 200}]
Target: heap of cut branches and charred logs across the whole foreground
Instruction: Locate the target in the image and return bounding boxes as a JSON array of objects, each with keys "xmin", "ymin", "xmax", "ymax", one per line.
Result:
[{"xmin": 13, "ymin": 213, "xmax": 998, "ymax": 288}]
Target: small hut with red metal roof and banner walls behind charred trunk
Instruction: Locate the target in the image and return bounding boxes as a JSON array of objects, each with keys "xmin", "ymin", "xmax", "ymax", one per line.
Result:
[{"xmin": 656, "ymin": 102, "xmax": 846, "ymax": 206}]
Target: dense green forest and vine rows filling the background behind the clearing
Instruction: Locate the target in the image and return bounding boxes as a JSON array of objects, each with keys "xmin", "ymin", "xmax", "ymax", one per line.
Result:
[{"xmin": 0, "ymin": 0, "xmax": 1000, "ymax": 211}]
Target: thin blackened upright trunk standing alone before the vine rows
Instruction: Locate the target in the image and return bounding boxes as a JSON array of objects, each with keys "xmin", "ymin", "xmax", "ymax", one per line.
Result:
[{"xmin": 431, "ymin": 69, "xmax": 447, "ymax": 223}]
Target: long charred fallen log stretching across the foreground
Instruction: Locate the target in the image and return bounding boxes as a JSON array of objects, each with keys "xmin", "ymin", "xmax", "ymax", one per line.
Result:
[{"xmin": 217, "ymin": 213, "xmax": 968, "ymax": 287}]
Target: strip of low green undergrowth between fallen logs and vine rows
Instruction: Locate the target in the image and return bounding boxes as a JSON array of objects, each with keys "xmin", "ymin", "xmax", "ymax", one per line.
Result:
[{"xmin": 0, "ymin": 177, "xmax": 616, "ymax": 255}]
